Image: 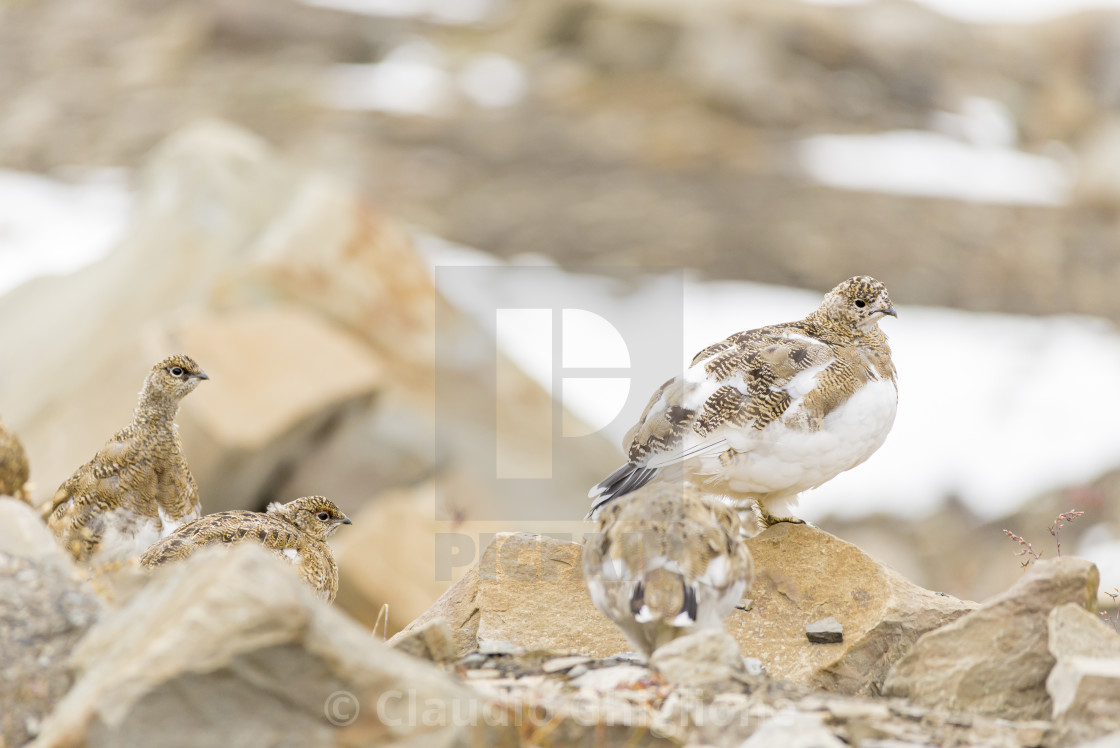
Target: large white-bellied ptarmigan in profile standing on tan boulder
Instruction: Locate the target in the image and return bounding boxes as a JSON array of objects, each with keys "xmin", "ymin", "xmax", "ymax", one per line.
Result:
[{"xmin": 588, "ymin": 275, "xmax": 898, "ymax": 526}]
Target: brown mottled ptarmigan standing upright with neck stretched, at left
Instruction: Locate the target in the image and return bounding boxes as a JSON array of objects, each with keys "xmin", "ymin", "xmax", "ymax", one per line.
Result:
[{"xmin": 45, "ymin": 356, "xmax": 209, "ymax": 565}]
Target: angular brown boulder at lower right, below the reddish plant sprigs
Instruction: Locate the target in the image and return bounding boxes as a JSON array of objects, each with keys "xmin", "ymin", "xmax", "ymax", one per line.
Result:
[{"xmin": 884, "ymin": 558, "xmax": 1100, "ymax": 719}]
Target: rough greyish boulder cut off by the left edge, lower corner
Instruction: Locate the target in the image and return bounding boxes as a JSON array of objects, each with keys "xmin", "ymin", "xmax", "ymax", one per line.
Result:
[{"xmin": 0, "ymin": 498, "xmax": 102, "ymax": 746}]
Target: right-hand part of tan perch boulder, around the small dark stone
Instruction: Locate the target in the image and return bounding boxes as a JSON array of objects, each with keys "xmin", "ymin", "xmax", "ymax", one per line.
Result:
[{"xmin": 725, "ymin": 523, "xmax": 977, "ymax": 694}]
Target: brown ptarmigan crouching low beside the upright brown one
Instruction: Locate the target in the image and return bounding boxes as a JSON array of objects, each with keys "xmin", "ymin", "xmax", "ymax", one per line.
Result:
[{"xmin": 140, "ymin": 496, "xmax": 352, "ymax": 602}]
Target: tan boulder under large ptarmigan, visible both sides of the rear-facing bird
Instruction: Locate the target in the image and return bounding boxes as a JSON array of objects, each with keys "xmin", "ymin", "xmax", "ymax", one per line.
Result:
[{"xmin": 404, "ymin": 523, "xmax": 976, "ymax": 694}]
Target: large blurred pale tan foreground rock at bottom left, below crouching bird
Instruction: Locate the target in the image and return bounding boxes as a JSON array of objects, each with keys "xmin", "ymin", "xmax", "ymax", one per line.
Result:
[{"xmin": 32, "ymin": 545, "xmax": 516, "ymax": 748}]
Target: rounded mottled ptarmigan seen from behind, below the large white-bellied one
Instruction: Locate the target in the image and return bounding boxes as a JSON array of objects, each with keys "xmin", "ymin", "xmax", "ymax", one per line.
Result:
[{"xmin": 584, "ymin": 481, "xmax": 753, "ymax": 656}]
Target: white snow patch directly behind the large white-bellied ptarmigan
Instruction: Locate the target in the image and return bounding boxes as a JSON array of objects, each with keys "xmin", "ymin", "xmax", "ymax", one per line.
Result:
[{"xmin": 419, "ymin": 236, "xmax": 1120, "ymax": 520}]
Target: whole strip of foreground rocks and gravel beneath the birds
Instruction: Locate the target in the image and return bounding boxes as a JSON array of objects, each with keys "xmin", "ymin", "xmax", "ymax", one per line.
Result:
[{"xmin": 0, "ymin": 490, "xmax": 1120, "ymax": 748}]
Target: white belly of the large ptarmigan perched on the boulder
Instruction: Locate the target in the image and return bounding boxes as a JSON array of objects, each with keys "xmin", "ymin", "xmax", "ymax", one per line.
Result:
[{"xmin": 697, "ymin": 380, "xmax": 898, "ymax": 495}]
